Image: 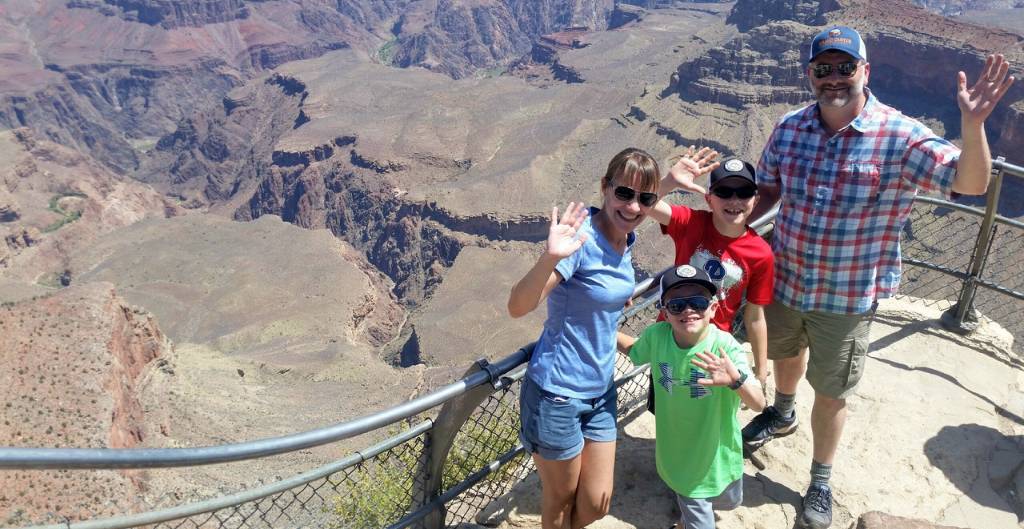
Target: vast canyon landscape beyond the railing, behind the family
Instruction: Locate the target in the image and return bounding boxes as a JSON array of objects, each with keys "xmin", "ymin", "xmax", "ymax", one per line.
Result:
[{"xmin": 0, "ymin": 0, "xmax": 1024, "ymax": 523}]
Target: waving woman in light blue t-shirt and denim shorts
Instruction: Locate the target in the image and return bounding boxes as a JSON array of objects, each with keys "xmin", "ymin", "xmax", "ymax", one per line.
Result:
[{"xmin": 508, "ymin": 148, "xmax": 658, "ymax": 529}]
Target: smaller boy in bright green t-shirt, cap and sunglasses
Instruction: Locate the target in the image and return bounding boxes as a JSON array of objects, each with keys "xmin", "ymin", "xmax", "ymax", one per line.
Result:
[{"xmin": 616, "ymin": 265, "xmax": 765, "ymax": 529}]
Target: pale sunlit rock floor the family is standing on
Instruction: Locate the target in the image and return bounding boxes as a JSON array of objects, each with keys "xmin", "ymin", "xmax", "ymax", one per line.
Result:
[{"xmin": 465, "ymin": 297, "xmax": 1024, "ymax": 529}]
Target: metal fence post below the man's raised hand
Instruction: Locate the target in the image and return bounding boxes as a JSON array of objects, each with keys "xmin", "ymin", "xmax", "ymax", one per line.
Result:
[{"xmin": 939, "ymin": 157, "xmax": 1005, "ymax": 335}]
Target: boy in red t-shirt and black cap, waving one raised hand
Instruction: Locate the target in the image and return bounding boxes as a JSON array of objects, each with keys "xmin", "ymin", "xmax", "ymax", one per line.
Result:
[{"xmin": 648, "ymin": 154, "xmax": 774, "ymax": 411}]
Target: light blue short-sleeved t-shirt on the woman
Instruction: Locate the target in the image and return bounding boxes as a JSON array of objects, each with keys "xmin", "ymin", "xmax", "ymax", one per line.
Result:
[{"xmin": 526, "ymin": 208, "xmax": 636, "ymax": 399}]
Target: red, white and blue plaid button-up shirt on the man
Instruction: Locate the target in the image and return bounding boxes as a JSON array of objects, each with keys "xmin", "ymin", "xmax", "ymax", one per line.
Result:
[{"xmin": 757, "ymin": 91, "xmax": 959, "ymax": 314}]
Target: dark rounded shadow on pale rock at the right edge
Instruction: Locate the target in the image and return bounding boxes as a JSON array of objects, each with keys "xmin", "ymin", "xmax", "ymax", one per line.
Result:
[{"xmin": 925, "ymin": 424, "xmax": 1024, "ymax": 522}]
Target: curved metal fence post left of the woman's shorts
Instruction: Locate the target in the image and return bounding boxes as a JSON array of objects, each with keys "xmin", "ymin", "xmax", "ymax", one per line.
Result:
[{"xmin": 414, "ymin": 344, "xmax": 535, "ymax": 529}]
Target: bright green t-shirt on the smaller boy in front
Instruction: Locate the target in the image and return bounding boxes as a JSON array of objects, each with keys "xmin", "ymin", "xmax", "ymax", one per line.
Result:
[{"xmin": 630, "ymin": 321, "xmax": 751, "ymax": 498}]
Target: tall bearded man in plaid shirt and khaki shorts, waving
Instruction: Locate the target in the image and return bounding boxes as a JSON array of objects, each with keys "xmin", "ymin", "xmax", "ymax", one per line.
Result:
[{"xmin": 742, "ymin": 27, "xmax": 1014, "ymax": 529}]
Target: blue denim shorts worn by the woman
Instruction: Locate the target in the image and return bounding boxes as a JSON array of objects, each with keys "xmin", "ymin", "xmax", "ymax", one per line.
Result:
[{"xmin": 519, "ymin": 377, "xmax": 618, "ymax": 460}]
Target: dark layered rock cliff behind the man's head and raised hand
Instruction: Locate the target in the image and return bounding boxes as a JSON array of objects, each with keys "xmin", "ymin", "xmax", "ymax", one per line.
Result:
[{"xmin": 663, "ymin": 0, "xmax": 1024, "ymax": 159}]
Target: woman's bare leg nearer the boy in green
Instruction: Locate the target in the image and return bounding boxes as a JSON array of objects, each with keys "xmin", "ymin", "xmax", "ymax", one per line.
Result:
[{"xmin": 571, "ymin": 439, "xmax": 615, "ymax": 529}]
